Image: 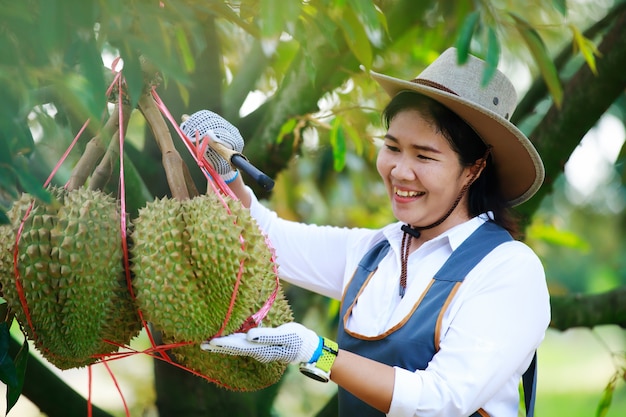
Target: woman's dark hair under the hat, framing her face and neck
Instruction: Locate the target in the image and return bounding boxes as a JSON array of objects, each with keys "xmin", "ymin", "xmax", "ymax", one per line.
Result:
[{"xmin": 382, "ymin": 91, "xmax": 519, "ymax": 236}]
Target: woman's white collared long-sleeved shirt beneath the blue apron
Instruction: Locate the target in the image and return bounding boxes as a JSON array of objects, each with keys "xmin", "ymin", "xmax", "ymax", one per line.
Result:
[{"xmin": 250, "ymin": 192, "xmax": 550, "ymax": 417}]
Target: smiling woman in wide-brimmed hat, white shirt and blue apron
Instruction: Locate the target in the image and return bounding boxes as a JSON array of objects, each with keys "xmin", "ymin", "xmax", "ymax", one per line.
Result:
[{"xmin": 182, "ymin": 49, "xmax": 550, "ymax": 417}]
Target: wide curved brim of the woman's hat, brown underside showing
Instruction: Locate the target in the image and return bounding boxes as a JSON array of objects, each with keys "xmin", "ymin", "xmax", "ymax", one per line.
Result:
[{"xmin": 370, "ymin": 71, "xmax": 545, "ymax": 206}]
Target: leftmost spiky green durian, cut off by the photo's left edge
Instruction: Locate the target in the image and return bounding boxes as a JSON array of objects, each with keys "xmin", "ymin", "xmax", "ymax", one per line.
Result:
[{"xmin": 0, "ymin": 188, "xmax": 141, "ymax": 369}]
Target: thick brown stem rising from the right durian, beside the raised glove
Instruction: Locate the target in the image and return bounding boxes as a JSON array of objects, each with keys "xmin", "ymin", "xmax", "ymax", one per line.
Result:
[{"xmin": 139, "ymin": 93, "xmax": 198, "ymax": 200}]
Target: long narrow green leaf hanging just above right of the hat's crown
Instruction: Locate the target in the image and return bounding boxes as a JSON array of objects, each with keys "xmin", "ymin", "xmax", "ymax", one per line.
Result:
[{"xmin": 509, "ymin": 13, "xmax": 563, "ymax": 108}]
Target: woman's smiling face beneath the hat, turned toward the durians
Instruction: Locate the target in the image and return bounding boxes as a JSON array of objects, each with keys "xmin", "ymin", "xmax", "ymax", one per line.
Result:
[{"xmin": 376, "ymin": 109, "xmax": 472, "ymax": 238}]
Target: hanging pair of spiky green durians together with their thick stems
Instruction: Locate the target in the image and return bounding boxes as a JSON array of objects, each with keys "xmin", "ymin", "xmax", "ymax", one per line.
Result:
[{"xmin": 0, "ymin": 87, "xmax": 292, "ymax": 391}]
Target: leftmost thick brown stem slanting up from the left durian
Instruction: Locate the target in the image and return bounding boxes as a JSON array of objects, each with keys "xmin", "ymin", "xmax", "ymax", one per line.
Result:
[{"xmin": 66, "ymin": 104, "xmax": 119, "ymax": 191}]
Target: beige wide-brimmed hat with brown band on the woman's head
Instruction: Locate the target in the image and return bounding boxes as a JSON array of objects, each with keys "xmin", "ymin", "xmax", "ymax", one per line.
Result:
[{"xmin": 371, "ymin": 48, "xmax": 545, "ymax": 206}]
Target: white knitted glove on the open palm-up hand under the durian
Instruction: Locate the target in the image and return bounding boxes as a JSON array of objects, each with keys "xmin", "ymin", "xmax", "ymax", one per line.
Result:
[{"xmin": 200, "ymin": 322, "xmax": 323, "ymax": 363}]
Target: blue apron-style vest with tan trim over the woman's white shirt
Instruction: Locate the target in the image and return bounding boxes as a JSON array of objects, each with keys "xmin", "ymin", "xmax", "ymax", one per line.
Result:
[{"xmin": 337, "ymin": 222, "xmax": 535, "ymax": 417}]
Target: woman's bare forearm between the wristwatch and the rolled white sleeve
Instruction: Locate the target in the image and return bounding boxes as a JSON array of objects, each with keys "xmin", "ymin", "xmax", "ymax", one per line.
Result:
[{"xmin": 330, "ymin": 349, "xmax": 395, "ymax": 413}]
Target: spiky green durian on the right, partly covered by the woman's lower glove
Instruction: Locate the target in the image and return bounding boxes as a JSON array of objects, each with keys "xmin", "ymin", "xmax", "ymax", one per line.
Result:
[{"xmin": 132, "ymin": 194, "xmax": 292, "ymax": 391}]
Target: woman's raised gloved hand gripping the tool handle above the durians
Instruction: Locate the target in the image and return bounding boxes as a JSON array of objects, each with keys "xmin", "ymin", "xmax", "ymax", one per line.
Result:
[{"xmin": 180, "ymin": 110, "xmax": 244, "ymax": 183}]
